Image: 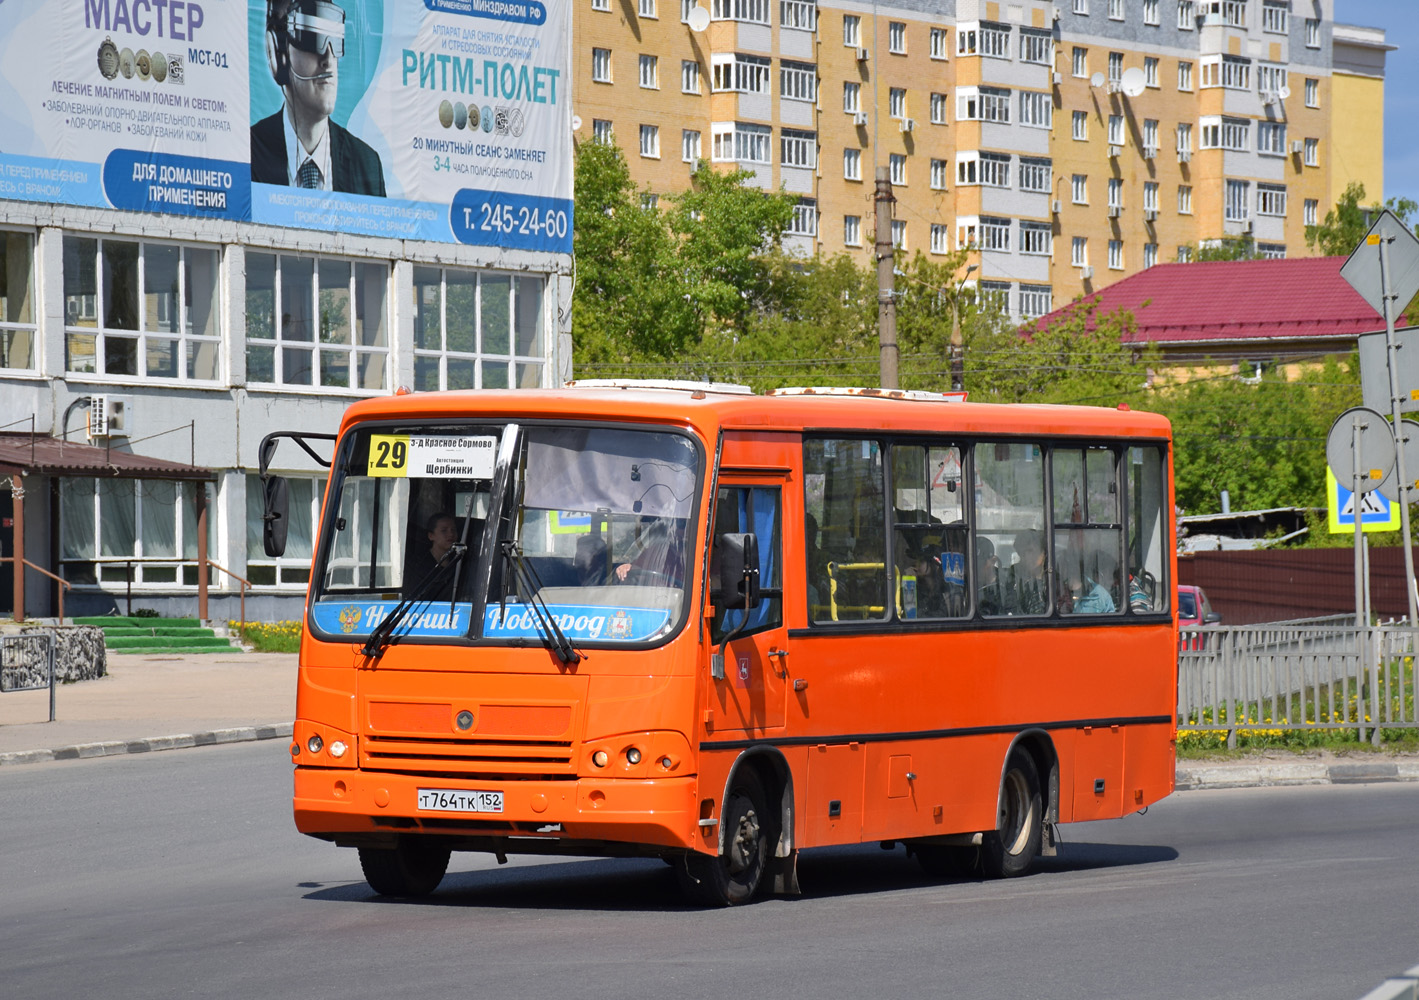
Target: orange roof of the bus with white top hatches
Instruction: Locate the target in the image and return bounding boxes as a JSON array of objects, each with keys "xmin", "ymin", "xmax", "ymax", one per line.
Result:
[{"xmin": 342, "ymin": 382, "xmax": 1169, "ymax": 438}]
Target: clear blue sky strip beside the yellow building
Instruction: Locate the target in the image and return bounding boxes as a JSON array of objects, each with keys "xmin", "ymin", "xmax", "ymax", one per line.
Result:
[{"xmin": 1335, "ymin": 0, "xmax": 1419, "ymax": 208}]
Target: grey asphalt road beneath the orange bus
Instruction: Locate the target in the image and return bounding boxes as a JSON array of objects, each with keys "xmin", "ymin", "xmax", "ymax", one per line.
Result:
[{"xmin": 0, "ymin": 740, "xmax": 1419, "ymax": 1000}]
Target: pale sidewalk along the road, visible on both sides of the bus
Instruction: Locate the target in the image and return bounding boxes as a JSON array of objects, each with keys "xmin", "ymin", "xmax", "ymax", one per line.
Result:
[{"xmin": 0, "ymin": 652, "xmax": 1419, "ymax": 791}]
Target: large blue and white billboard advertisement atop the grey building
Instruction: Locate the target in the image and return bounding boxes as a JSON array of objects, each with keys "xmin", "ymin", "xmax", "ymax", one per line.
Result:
[{"xmin": 0, "ymin": 0, "xmax": 572, "ymax": 252}]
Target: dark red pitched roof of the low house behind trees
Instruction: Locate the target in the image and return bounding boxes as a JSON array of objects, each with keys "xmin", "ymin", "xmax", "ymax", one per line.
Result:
[{"xmin": 1037, "ymin": 257, "xmax": 1385, "ymax": 345}]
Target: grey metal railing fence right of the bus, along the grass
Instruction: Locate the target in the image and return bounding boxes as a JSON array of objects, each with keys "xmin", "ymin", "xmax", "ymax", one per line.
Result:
[{"xmin": 1178, "ymin": 624, "xmax": 1419, "ymax": 746}]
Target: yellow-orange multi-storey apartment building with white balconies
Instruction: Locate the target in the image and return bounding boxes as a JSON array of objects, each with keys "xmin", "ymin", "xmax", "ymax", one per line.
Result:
[{"xmin": 573, "ymin": 0, "xmax": 1391, "ymax": 316}]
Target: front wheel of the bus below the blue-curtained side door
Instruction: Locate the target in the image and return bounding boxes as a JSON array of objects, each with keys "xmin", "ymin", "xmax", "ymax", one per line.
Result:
[{"xmin": 675, "ymin": 767, "xmax": 778, "ymax": 906}]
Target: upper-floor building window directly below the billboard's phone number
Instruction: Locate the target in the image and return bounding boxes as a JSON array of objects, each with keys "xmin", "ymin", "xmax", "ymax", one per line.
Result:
[{"xmin": 414, "ymin": 265, "xmax": 546, "ymax": 391}]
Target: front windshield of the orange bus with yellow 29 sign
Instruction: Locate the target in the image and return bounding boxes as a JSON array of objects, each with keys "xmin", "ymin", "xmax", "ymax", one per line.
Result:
[{"xmin": 311, "ymin": 424, "xmax": 701, "ymax": 645}]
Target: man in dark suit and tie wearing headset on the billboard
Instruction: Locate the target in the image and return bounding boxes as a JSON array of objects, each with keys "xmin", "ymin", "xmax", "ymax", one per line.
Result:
[{"xmin": 251, "ymin": 0, "xmax": 385, "ymax": 197}]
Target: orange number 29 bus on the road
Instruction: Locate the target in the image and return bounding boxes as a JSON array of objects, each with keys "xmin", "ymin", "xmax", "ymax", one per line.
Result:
[{"xmin": 263, "ymin": 382, "xmax": 1176, "ymax": 905}]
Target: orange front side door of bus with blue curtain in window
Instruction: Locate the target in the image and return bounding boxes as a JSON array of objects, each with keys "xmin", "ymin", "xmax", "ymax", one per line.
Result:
[{"xmin": 707, "ymin": 479, "xmax": 789, "ymax": 732}]
